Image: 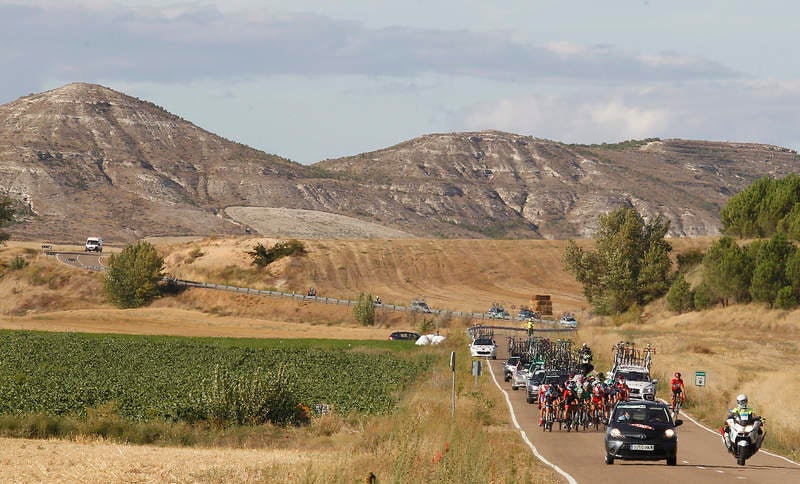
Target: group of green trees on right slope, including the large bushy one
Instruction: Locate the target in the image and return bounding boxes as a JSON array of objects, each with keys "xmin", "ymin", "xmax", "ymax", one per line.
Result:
[{"xmin": 563, "ymin": 175, "xmax": 800, "ymax": 315}]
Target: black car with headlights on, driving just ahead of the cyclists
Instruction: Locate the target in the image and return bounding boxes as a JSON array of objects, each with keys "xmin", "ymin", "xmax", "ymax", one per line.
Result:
[{"xmin": 606, "ymin": 400, "xmax": 683, "ymax": 466}]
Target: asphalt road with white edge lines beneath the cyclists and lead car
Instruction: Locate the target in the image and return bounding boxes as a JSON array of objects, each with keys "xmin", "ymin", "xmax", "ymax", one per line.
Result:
[{"xmin": 486, "ymin": 359, "xmax": 800, "ymax": 484}]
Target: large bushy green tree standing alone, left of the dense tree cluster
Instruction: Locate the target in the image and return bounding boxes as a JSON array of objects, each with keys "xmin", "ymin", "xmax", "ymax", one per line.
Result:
[{"xmin": 562, "ymin": 207, "xmax": 672, "ymax": 314}]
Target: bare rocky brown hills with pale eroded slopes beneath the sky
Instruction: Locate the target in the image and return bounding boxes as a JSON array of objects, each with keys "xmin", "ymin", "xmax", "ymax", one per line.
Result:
[{"xmin": 0, "ymin": 83, "xmax": 799, "ymax": 243}]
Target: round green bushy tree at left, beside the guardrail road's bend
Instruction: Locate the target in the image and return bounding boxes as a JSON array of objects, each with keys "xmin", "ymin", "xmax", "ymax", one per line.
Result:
[{"xmin": 104, "ymin": 241, "xmax": 164, "ymax": 308}]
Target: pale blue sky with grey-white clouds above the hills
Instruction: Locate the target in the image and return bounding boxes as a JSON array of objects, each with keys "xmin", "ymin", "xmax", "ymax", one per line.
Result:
[{"xmin": 0, "ymin": 0, "xmax": 800, "ymax": 164}]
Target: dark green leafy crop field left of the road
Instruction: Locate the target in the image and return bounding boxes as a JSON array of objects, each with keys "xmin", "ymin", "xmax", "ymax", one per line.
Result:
[{"xmin": 0, "ymin": 331, "xmax": 432, "ymax": 421}]
